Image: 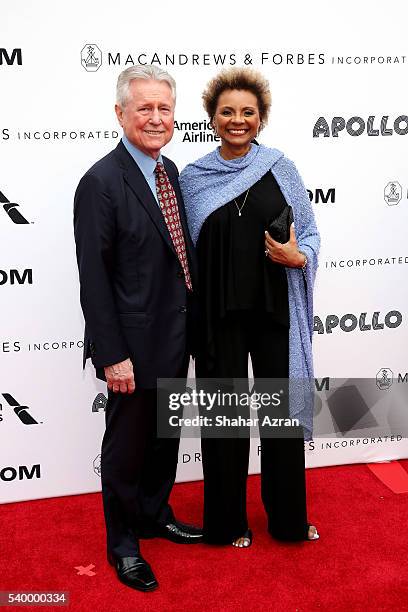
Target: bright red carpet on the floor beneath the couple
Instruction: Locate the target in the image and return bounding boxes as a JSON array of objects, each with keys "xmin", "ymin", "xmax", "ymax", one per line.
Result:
[{"xmin": 0, "ymin": 460, "xmax": 408, "ymax": 612}]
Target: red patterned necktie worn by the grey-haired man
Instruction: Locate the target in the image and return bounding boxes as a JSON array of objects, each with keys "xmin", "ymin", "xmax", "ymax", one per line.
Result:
[{"xmin": 154, "ymin": 162, "xmax": 193, "ymax": 291}]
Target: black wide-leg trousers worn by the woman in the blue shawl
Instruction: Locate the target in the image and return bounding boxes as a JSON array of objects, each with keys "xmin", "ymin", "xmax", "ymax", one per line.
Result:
[{"xmin": 196, "ymin": 311, "xmax": 308, "ymax": 544}]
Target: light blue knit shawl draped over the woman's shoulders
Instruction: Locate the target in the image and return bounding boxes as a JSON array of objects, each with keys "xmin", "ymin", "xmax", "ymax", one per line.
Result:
[{"xmin": 180, "ymin": 144, "xmax": 320, "ymax": 440}]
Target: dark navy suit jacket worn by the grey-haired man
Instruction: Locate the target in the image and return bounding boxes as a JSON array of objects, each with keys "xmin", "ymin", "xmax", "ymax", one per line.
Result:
[{"xmin": 74, "ymin": 143, "xmax": 197, "ymax": 388}]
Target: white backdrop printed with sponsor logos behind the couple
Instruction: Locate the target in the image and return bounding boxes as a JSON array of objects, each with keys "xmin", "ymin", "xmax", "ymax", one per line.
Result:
[{"xmin": 0, "ymin": 0, "xmax": 408, "ymax": 502}]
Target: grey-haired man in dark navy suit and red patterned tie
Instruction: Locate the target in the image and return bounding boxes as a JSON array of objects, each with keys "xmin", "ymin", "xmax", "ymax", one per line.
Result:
[{"xmin": 74, "ymin": 66, "xmax": 202, "ymax": 591}]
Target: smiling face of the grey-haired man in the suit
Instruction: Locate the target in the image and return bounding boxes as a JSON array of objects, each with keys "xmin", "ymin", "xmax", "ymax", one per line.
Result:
[{"xmin": 115, "ymin": 79, "xmax": 175, "ymax": 159}]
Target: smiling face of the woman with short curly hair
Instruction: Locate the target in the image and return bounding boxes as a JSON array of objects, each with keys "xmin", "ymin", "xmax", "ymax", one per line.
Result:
[{"xmin": 213, "ymin": 89, "xmax": 261, "ymax": 150}]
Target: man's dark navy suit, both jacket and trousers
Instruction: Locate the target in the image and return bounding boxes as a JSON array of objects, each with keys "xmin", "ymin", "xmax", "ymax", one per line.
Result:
[{"xmin": 74, "ymin": 143, "xmax": 196, "ymax": 557}]
